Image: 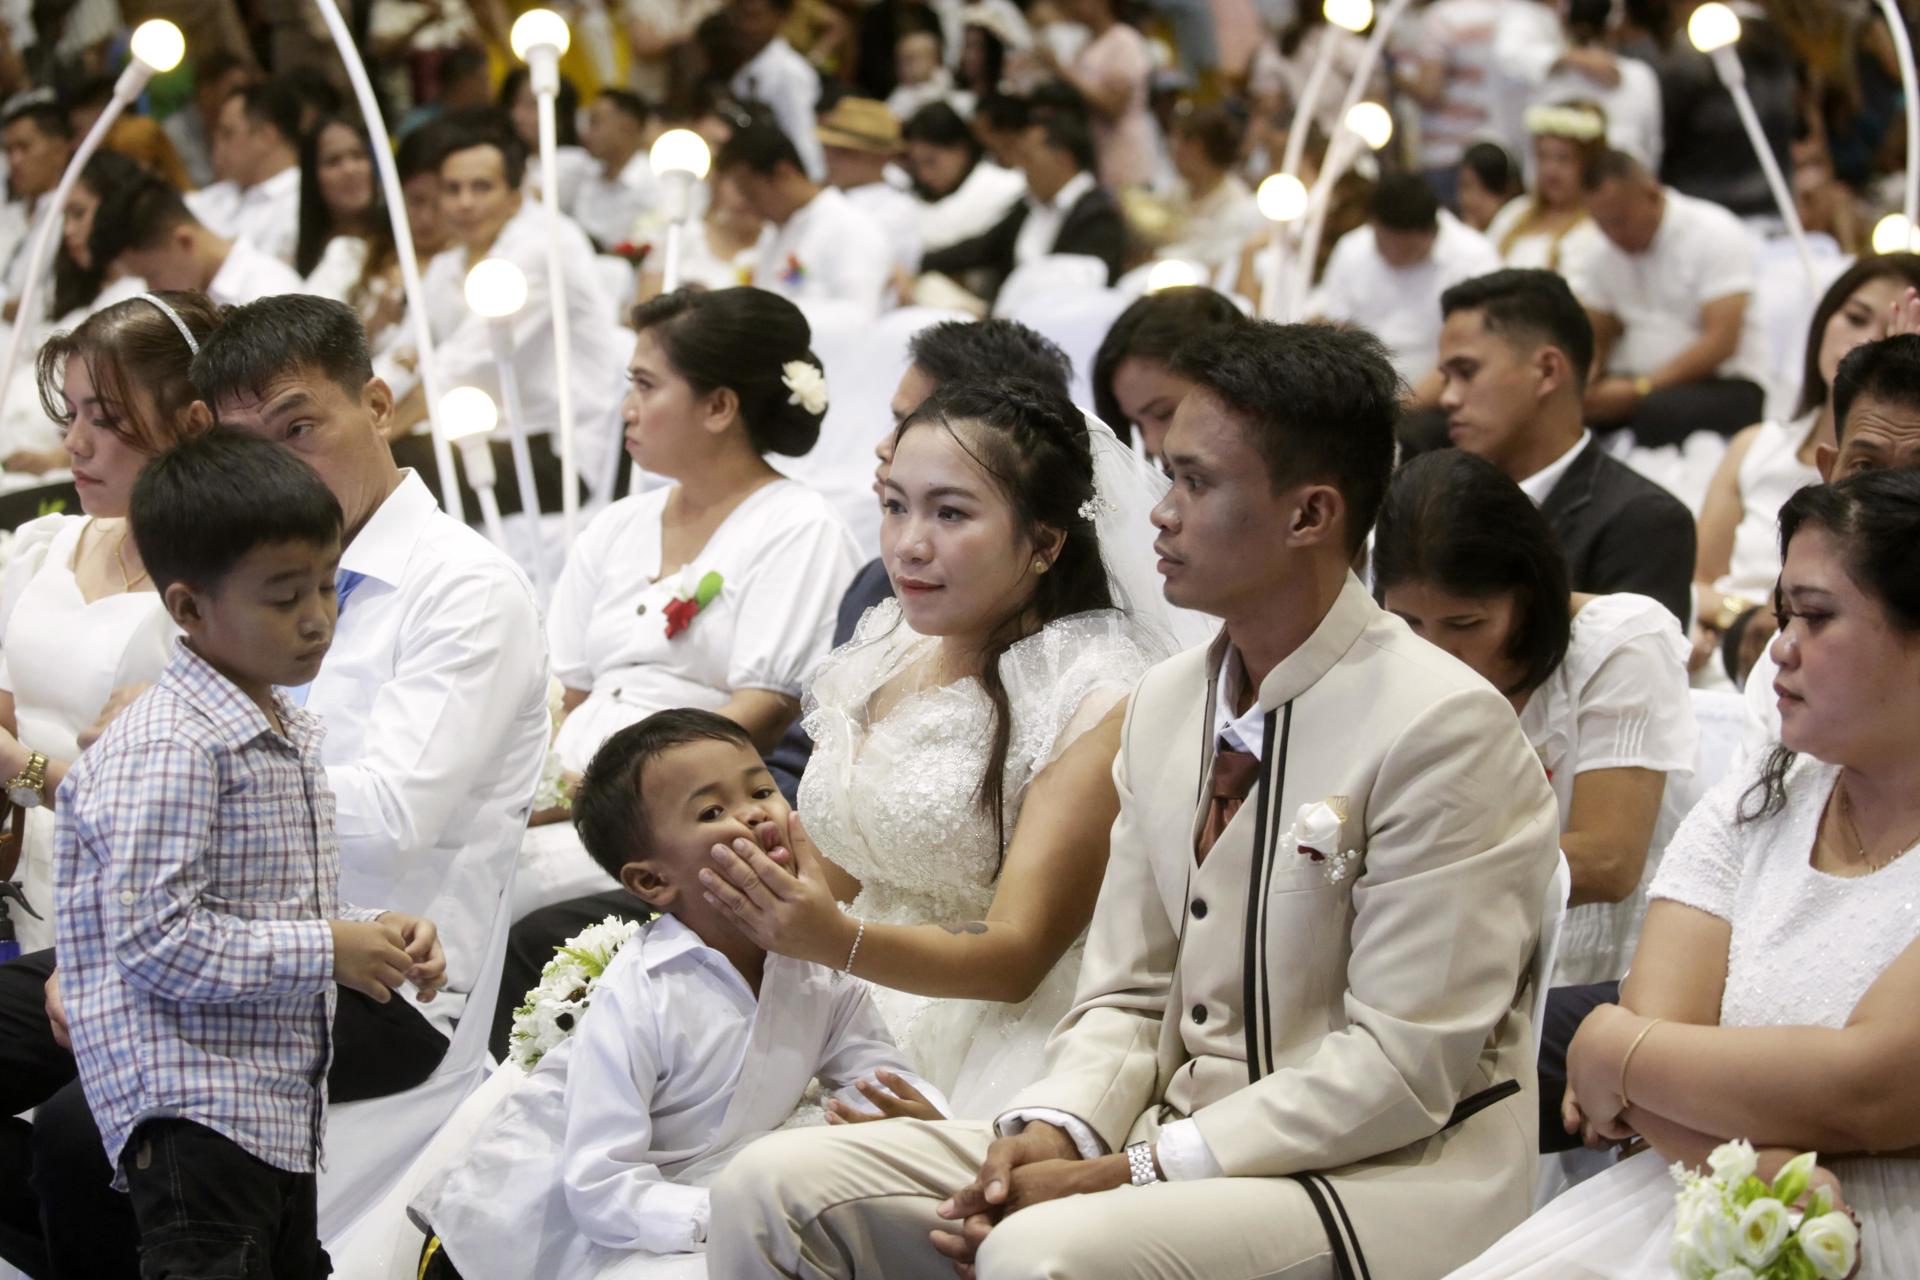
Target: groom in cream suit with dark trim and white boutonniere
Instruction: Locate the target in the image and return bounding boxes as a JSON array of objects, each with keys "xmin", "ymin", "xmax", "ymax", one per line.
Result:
[{"xmin": 708, "ymin": 324, "xmax": 1557, "ymax": 1280}]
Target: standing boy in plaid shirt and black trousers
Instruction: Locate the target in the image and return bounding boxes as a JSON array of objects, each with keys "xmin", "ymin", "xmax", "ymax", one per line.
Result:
[{"xmin": 54, "ymin": 430, "xmax": 445, "ymax": 1280}]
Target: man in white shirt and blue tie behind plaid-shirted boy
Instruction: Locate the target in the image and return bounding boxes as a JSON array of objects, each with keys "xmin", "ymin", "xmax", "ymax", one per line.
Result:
[{"xmin": 0, "ymin": 296, "xmax": 547, "ymax": 1276}]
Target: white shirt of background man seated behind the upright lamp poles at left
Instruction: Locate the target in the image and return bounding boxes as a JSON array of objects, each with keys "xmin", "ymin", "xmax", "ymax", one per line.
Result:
[{"xmin": 422, "ymin": 194, "xmax": 632, "ymax": 493}]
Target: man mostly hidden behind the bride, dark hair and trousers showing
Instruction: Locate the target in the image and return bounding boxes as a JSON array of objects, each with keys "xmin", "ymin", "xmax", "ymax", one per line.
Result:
[{"xmin": 490, "ymin": 320, "xmax": 1073, "ymax": 1061}]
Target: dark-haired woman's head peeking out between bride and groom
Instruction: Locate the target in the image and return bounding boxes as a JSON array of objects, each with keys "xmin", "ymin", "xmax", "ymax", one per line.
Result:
[{"xmin": 1092, "ymin": 286, "xmax": 1246, "ymax": 459}]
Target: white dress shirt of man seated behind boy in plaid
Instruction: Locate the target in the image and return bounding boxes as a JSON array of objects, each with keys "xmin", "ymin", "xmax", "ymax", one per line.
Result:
[{"xmin": 305, "ymin": 470, "xmax": 549, "ymax": 1031}]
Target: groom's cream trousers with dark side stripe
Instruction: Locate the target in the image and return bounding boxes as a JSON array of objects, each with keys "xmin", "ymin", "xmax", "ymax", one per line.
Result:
[{"xmin": 707, "ymin": 1121, "xmax": 1334, "ymax": 1280}]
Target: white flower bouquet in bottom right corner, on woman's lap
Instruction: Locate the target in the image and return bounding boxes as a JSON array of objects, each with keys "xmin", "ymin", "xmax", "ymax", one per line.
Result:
[{"xmin": 1670, "ymin": 1140, "xmax": 1860, "ymax": 1280}]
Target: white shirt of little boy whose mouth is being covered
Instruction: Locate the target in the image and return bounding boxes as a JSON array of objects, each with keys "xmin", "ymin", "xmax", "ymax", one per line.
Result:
[{"xmin": 409, "ymin": 915, "xmax": 947, "ymax": 1280}]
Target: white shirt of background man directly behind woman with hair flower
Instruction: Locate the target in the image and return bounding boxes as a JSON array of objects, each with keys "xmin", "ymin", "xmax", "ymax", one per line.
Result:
[{"xmin": 753, "ymin": 186, "xmax": 893, "ymax": 320}]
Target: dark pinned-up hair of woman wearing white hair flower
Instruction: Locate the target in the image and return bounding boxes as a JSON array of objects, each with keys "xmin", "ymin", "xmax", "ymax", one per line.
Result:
[{"xmin": 632, "ymin": 288, "xmax": 826, "ymax": 459}]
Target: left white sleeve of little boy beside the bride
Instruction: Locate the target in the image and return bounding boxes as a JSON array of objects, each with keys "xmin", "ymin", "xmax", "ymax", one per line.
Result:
[{"xmin": 561, "ymin": 971, "xmax": 708, "ymax": 1253}]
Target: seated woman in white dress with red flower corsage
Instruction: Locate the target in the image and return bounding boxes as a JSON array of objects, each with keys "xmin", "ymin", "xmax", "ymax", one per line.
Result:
[{"xmin": 511, "ymin": 288, "xmax": 860, "ymax": 921}]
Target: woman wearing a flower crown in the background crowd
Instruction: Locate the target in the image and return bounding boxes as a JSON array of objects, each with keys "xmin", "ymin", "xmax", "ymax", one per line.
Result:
[{"xmin": 1486, "ymin": 102, "xmax": 1607, "ymax": 274}]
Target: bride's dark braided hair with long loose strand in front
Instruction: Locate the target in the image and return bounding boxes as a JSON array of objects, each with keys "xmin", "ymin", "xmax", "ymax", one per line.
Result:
[{"xmin": 893, "ymin": 378, "xmax": 1116, "ymax": 852}]
